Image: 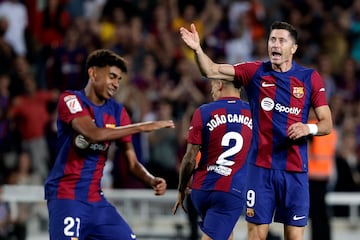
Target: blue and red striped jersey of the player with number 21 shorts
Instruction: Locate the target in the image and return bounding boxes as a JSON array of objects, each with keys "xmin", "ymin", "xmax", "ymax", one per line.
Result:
[{"xmin": 45, "ymin": 91, "xmax": 131, "ymax": 202}]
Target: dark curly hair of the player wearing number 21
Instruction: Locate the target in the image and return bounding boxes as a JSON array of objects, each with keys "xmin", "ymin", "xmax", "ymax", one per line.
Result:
[{"xmin": 86, "ymin": 49, "xmax": 127, "ymax": 73}]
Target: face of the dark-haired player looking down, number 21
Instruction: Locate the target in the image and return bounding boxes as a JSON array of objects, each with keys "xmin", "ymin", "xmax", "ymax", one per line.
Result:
[{"xmin": 93, "ymin": 66, "xmax": 123, "ymax": 99}]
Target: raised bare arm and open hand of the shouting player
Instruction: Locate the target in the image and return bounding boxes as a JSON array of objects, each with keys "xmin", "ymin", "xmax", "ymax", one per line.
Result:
[{"xmin": 180, "ymin": 24, "xmax": 235, "ymax": 81}]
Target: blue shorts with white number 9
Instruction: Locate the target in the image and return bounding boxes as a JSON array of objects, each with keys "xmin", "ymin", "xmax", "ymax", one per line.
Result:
[{"xmin": 246, "ymin": 164, "xmax": 309, "ymax": 227}]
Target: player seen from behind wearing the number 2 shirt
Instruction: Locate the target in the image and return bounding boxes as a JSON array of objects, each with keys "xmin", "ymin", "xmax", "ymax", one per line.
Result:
[{"xmin": 173, "ymin": 77, "xmax": 252, "ymax": 240}]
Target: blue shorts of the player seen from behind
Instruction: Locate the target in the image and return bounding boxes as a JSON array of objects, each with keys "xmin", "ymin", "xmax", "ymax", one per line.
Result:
[{"xmin": 191, "ymin": 189, "xmax": 244, "ymax": 240}]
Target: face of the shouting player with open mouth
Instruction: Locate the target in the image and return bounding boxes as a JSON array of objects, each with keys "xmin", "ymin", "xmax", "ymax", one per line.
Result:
[{"xmin": 268, "ymin": 29, "xmax": 297, "ymax": 68}]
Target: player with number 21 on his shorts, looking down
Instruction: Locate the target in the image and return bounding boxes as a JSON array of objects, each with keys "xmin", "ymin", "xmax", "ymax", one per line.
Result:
[{"xmin": 45, "ymin": 49, "xmax": 174, "ymax": 240}]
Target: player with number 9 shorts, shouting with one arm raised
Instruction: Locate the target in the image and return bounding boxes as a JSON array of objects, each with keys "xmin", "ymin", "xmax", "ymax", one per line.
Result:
[{"xmin": 180, "ymin": 21, "xmax": 332, "ymax": 240}]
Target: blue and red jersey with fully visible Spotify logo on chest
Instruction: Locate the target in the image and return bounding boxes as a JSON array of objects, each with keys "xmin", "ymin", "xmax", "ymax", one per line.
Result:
[{"xmin": 234, "ymin": 61, "xmax": 327, "ymax": 172}]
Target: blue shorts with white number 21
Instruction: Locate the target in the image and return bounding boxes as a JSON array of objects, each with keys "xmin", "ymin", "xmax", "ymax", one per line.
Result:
[{"xmin": 47, "ymin": 199, "xmax": 136, "ymax": 240}]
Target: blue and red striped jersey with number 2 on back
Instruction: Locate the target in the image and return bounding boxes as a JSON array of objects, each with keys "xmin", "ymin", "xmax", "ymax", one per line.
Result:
[{"xmin": 188, "ymin": 98, "xmax": 252, "ymax": 196}]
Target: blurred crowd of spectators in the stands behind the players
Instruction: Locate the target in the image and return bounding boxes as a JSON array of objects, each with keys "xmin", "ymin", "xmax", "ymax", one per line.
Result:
[{"xmin": 0, "ymin": 0, "xmax": 360, "ymax": 238}]
